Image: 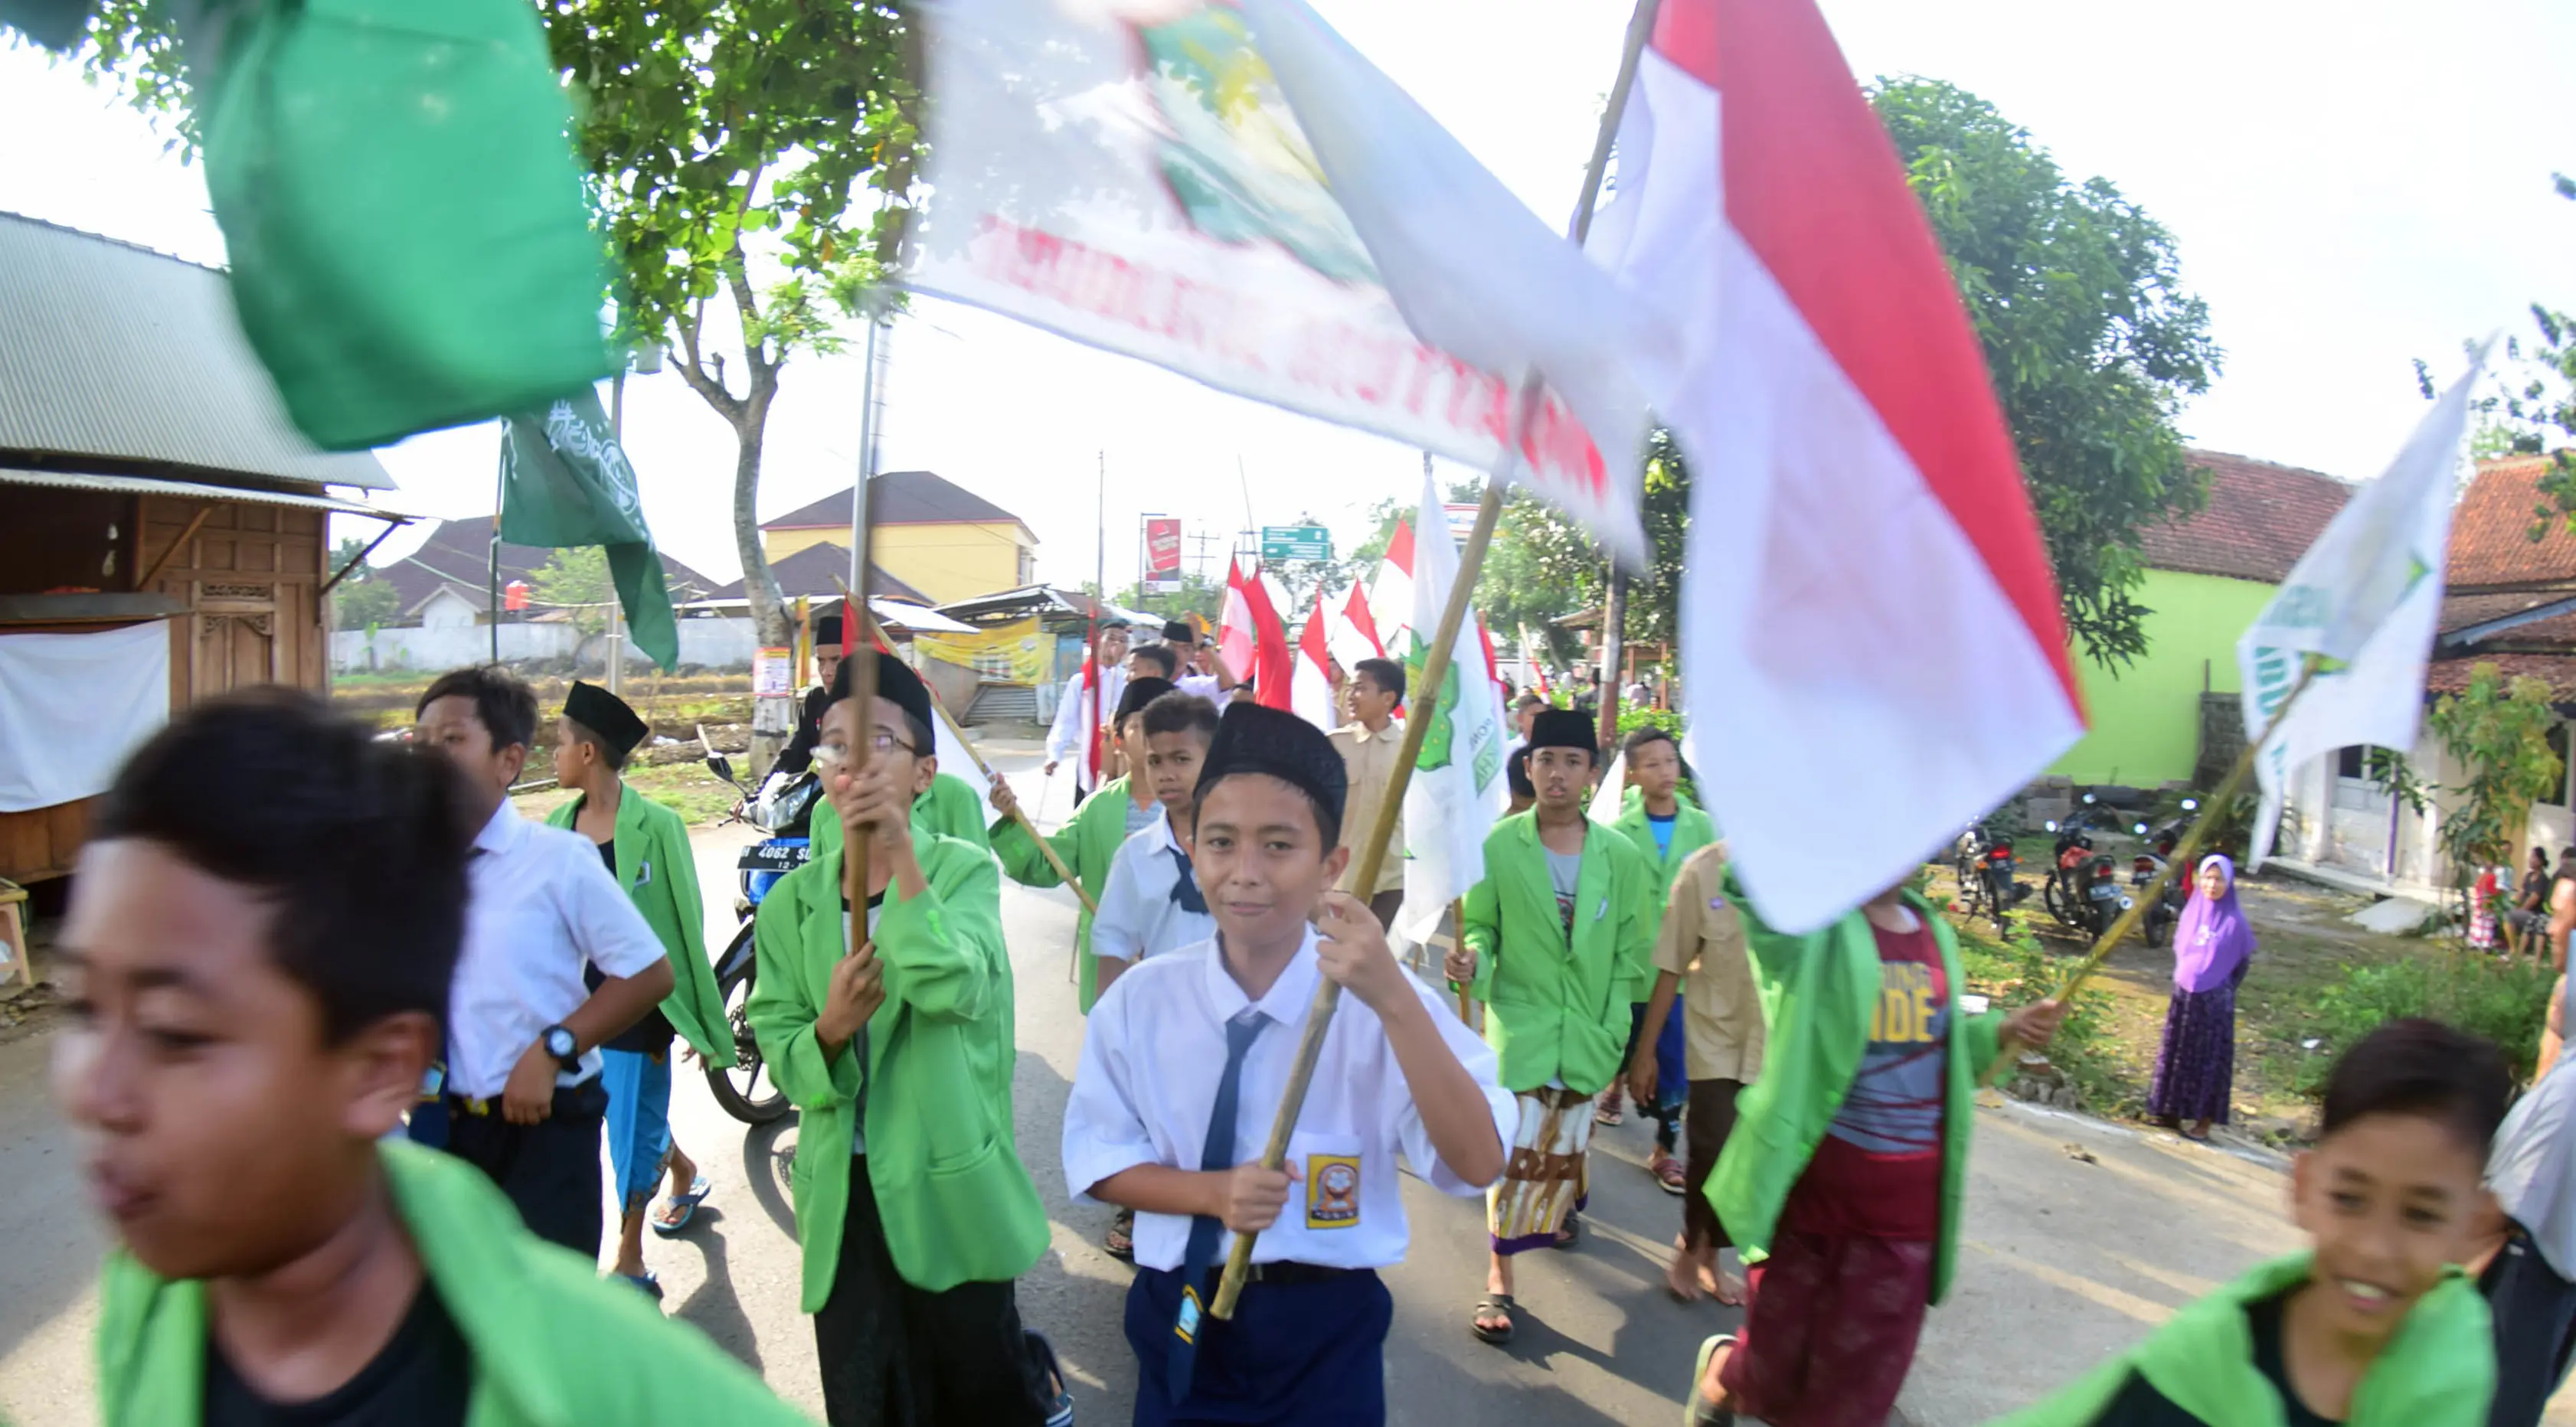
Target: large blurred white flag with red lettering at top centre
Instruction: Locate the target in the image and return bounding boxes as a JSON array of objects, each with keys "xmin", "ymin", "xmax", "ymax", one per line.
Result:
[{"xmin": 904, "ymin": 0, "xmax": 1679, "ymax": 561}]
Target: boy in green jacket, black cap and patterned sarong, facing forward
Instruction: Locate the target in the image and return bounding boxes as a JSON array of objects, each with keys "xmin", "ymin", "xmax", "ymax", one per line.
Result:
[{"xmin": 1448, "ymin": 708, "xmax": 1656, "ymax": 1344}]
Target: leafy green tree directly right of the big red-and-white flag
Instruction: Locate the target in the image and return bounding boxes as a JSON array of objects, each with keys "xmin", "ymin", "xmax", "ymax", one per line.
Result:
[{"xmin": 1870, "ymin": 77, "xmax": 2221, "ymax": 667}]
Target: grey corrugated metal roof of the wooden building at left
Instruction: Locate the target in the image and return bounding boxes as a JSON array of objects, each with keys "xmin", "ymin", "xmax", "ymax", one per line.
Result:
[{"xmin": 0, "ymin": 214, "xmax": 394, "ymax": 489}]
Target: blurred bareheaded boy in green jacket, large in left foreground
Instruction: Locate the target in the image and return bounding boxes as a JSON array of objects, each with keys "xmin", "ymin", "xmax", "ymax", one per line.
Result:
[{"xmin": 54, "ymin": 687, "xmax": 801, "ymax": 1427}]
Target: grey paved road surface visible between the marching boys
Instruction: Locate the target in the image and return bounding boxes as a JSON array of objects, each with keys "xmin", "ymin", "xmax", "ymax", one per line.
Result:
[{"xmin": 20, "ymin": 755, "xmax": 2524, "ymax": 1427}]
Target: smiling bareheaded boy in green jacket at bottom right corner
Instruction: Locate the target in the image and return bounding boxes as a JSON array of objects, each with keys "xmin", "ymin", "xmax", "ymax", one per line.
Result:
[{"xmin": 2002, "ymin": 1020, "xmax": 2512, "ymax": 1427}]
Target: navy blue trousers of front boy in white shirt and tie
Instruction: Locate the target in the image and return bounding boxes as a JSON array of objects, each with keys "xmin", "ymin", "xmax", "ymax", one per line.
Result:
[{"xmin": 1126, "ymin": 1267, "xmax": 1396, "ymax": 1427}]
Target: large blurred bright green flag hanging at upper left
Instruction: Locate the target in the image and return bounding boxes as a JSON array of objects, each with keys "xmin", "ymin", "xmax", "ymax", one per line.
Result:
[{"xmin": 188, "ymin": 0, "xmax": 616, "ymax": 451}]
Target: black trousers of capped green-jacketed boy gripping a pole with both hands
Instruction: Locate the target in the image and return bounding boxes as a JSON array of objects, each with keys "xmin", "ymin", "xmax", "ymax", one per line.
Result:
[{"xmin": 814, "ymin": 1154, "xmax": 1051, "ymax": 1427}]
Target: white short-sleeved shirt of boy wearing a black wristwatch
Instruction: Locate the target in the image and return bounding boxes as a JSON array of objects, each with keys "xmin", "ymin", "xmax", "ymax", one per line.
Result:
[{"xmin": 448, "ymin": 798, "xmax": 662, "ymax": 1100}]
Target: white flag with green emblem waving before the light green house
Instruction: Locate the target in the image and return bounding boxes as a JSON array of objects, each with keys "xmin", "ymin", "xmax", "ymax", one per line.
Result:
[{"xmin": 2236, "ymin": 348, "xmax": 2486, "ymax": 870}]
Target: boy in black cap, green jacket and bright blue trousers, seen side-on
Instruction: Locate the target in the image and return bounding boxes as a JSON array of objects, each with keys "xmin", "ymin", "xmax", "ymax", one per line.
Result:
[{"xmin": 546, "ymin": 680, "xmax": 734, "ymax": 1298}]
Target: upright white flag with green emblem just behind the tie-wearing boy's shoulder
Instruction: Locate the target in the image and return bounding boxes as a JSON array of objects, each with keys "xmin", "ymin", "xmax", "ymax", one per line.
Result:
[{"xmin": 1396, "ymin": 463, "xmax": 1512, "ymax": 942}]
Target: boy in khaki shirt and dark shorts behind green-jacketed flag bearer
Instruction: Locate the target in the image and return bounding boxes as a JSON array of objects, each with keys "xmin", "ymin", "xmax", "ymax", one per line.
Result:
[{"xmin": 1628, "ymin": 842, "xmax": 1762, "ymax": 1303}]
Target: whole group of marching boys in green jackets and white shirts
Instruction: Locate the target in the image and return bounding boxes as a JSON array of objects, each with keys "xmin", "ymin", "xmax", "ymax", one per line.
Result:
[{"xmin": 35, "ymin": 625, "xmax": 2576, "ymax": 1427}]
